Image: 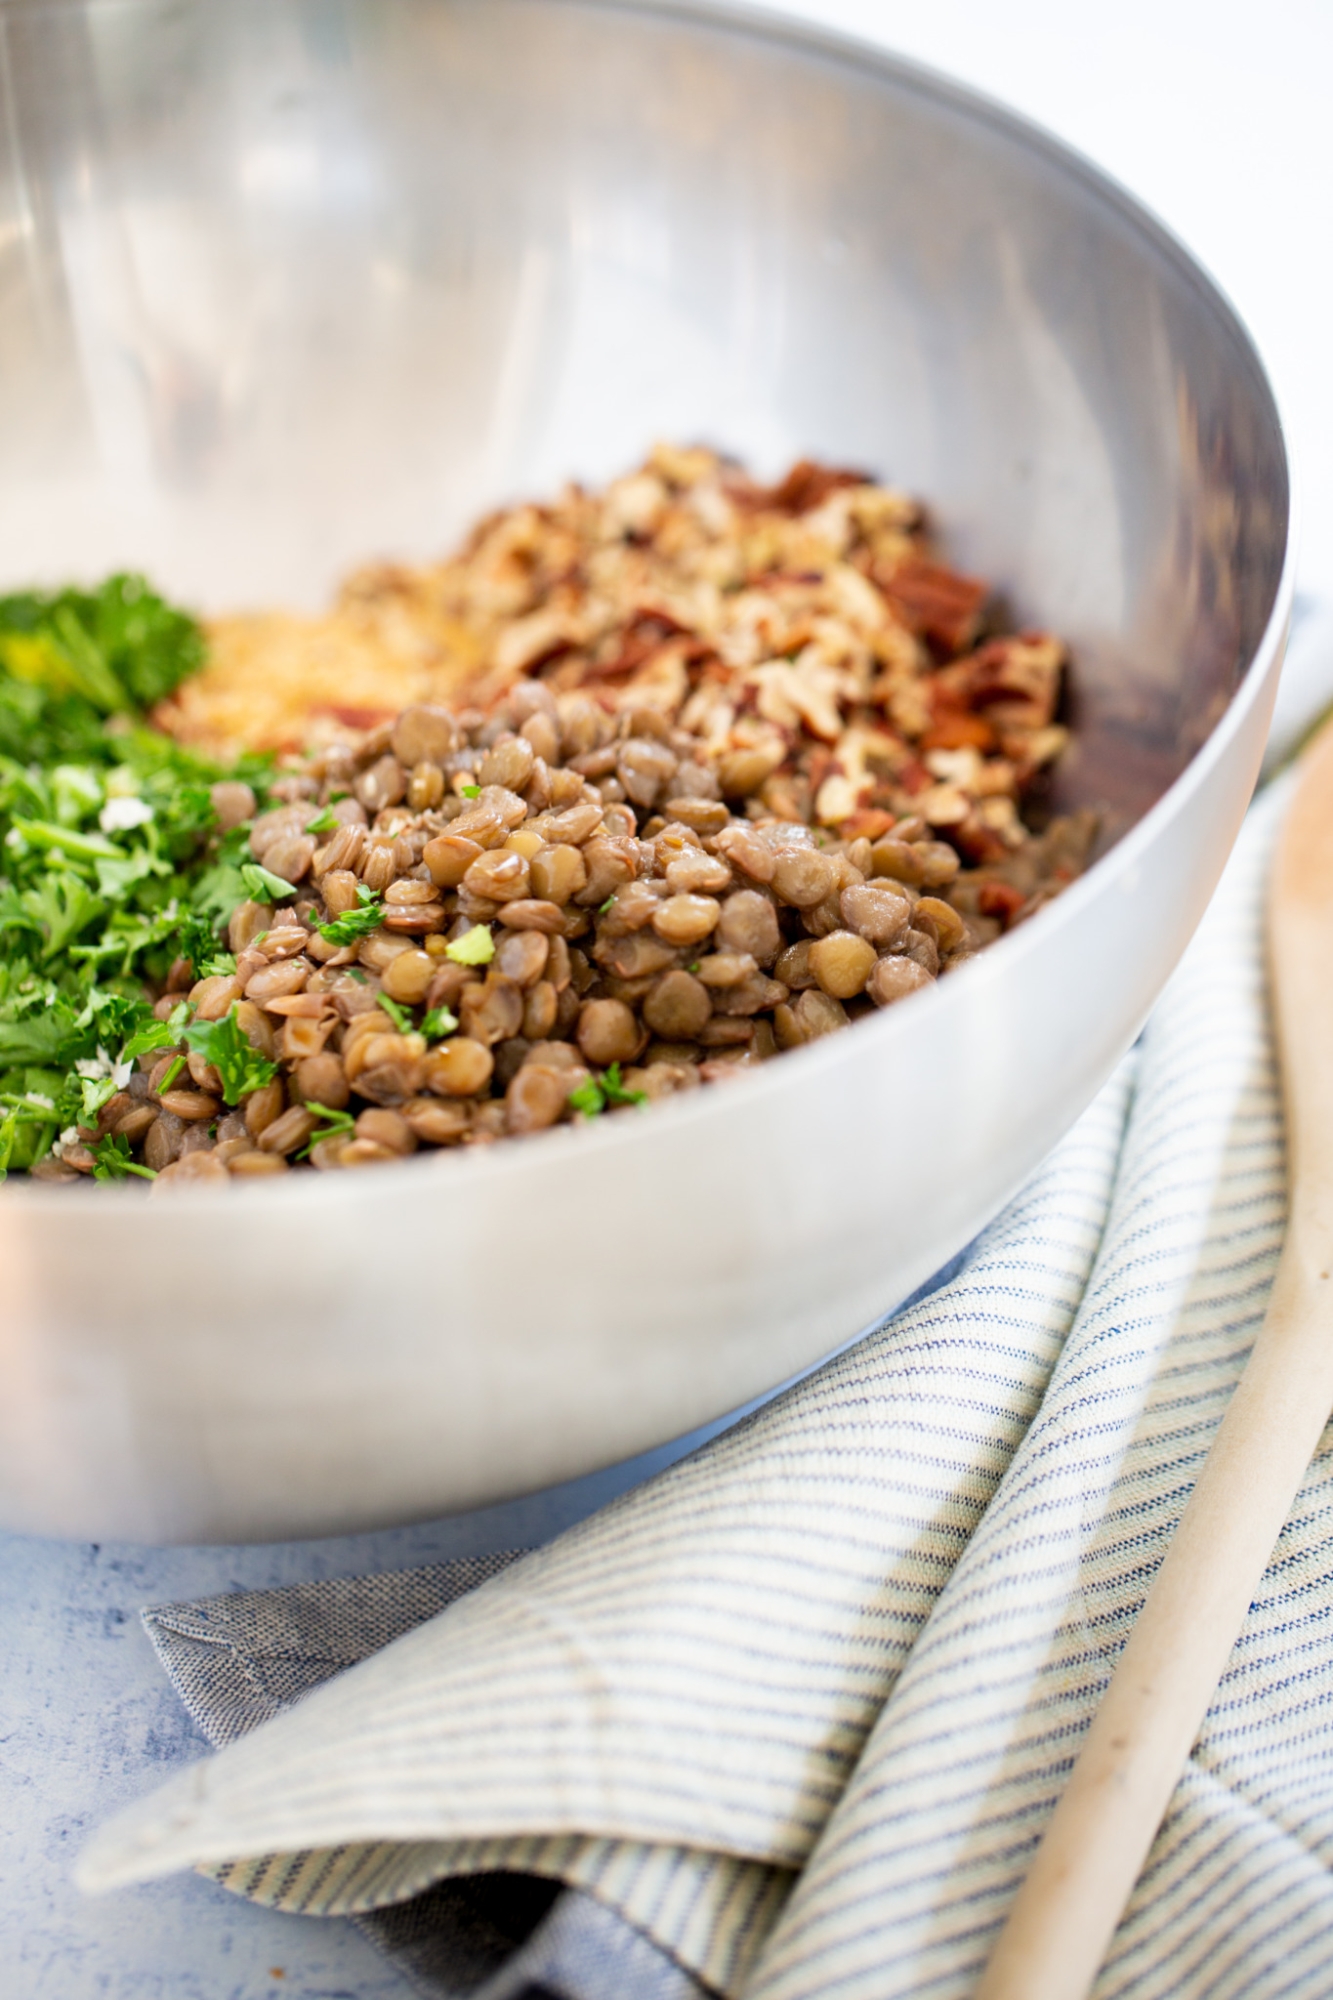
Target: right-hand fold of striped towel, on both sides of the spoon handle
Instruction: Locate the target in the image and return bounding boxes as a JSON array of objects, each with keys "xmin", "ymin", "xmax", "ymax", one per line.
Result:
[{"xmin": 745, "ymin": 780, "xmax": 1304, "ymax": 2000}]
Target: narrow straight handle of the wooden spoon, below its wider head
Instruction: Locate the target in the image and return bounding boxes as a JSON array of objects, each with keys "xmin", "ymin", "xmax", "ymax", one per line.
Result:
[{"xmin": 977, "ymin": 1242, "xmax": 1333, "ymax": 2000}]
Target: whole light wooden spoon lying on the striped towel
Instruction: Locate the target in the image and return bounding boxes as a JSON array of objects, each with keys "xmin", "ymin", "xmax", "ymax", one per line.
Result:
[{"xmin": 977, "ymin": 724, "xmax": 1333, "ymax": 2000}]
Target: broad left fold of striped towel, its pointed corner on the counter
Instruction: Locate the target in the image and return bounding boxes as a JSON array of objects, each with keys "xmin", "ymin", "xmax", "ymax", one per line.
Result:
[{"xmin": 82, "ymin": 1048, "xmax": 1129, "ymax": 1992}]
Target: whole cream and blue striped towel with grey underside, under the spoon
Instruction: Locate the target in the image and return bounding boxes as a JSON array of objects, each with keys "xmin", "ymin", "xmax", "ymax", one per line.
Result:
[{"xmin": 82, "ymin": 792, "xmax": 1312, "ymax": 2000}]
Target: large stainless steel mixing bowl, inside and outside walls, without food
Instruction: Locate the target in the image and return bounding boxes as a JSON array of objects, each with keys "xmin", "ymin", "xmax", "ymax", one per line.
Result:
[{"xmin": 0, "ymin": 0, "xmax": 1291, "ymax": 1540}]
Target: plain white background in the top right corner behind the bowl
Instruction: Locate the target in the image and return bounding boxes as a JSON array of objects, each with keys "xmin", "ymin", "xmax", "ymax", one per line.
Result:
[{"xmin": 736, "ymin": 0, "xmax": 1333, "ymax": 600}]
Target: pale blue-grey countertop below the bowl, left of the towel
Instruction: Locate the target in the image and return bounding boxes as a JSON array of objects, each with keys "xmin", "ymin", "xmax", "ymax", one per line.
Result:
[{"xmin": 0, "ymin": 1424, "xmax": 723, "ymax": 2000}]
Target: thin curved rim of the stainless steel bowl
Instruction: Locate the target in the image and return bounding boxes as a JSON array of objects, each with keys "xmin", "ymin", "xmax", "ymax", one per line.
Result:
[{"xmin": 0, "ymin": 0, "xmax": 1301, "ymax": 1220}]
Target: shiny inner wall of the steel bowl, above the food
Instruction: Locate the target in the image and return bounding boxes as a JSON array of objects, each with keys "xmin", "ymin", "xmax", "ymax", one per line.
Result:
[{"xmin": 0, "ymin": 0, "xmax": 1287, "ymax": 838}]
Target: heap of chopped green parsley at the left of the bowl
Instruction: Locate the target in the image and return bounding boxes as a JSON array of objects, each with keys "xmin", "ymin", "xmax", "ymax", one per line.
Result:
[{"xmin": 0, "ymin": 576, "xmax": 278, "ymax": 1178}]
